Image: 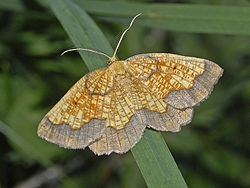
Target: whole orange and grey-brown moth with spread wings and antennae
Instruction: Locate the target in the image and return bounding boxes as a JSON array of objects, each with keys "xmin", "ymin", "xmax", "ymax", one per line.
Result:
[{"xmin": 37, "ymin": 14, "xmax": 223, "ymax": 155}]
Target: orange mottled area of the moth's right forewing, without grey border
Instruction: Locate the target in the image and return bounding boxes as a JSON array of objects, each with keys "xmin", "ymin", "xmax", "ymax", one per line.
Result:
[{"xmin": 126, "ymin": 53, "xmax": 205, "ymax": 98}]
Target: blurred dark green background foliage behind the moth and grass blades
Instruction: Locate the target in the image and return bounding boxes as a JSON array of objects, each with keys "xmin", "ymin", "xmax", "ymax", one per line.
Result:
[{"xmin": 0, "ymin": 0, "xmax": 250, "ymax": 187}]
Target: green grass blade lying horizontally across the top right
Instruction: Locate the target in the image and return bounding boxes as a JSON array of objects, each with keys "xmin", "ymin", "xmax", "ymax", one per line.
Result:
[{"xmin": 74, "ymin": 0, "xmax": 250, "ymax": 35}]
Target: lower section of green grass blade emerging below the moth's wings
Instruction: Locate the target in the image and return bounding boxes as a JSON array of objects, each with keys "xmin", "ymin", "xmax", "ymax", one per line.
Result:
[{"xmin": 132, "ymin": 129, "xmax": 187, "ymax": 188}]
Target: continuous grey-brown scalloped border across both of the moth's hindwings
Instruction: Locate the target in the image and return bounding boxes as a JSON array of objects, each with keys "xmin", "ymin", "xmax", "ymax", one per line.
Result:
[{"xmin": 89, "ymin": 106, "xmax": 193, "ymax": 155}]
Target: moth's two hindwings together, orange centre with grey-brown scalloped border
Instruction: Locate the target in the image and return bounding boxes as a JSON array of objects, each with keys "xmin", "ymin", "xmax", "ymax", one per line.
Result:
[{"xmin": 89, "ymin": 76, "xmax": 193, "ymax": 155}]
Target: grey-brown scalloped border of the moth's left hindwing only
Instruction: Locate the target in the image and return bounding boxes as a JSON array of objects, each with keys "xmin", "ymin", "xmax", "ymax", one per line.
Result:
[{"xmin": 89, "ymin": 112, "xmax": 146, "ymax": 155}]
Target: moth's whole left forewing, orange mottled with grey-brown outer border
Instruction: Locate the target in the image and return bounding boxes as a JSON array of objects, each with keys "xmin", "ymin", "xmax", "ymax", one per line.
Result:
[{"xmin": 38, "ymin": 69, "xmax": 113, "ymax": 148}]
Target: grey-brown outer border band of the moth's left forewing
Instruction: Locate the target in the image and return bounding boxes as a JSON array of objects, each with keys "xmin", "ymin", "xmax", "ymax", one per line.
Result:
[{"xmin": 37, "ymin": 116, "xmax": 106, "ymax": 149}]
